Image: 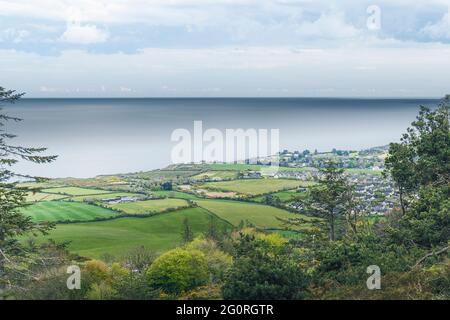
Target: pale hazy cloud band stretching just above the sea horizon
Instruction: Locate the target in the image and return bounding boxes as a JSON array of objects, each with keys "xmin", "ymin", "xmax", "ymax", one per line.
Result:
[{"xmin": 0, "ymin": 44, "xmax": 450, "ymax": 97}]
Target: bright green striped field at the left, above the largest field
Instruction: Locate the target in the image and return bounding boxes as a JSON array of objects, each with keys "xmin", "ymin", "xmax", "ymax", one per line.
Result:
[{"xmin": 22, "ymin": 201, "xmax": 118, "ymax": 222}]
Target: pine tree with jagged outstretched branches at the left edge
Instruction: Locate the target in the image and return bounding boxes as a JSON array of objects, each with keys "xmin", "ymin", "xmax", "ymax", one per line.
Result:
[{"xmin": 0, "ymin": 87, "xmax": 56, "ymax": 289}]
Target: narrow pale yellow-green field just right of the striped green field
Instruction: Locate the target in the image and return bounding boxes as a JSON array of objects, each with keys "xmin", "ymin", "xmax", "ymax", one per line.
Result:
[{"xmin": 109, "ymin": 199, "xmax": 188, "ymax": 214}]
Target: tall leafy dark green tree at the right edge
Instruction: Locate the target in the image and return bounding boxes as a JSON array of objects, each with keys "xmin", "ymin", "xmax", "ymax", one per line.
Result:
[{"xmin": 386, "ymin": 96, "xmax": 450, "ymax": 248}]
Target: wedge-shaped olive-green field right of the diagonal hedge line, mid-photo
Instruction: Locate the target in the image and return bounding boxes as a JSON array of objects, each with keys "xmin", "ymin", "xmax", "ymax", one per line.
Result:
[{"xmin": 195, "ymin": 200, "xmax": 312, "ymax": 228}]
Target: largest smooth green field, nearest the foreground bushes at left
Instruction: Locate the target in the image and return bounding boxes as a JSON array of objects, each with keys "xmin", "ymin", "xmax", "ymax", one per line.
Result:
[{"xmin": 29, "ymin": 208, "xmax": 230, "ymax": 258}]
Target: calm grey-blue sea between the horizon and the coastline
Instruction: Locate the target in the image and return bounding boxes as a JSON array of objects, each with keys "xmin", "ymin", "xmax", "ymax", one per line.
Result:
[{"xmin": 4, "ymin": 98, "xmax": 437, "ymax": 177}]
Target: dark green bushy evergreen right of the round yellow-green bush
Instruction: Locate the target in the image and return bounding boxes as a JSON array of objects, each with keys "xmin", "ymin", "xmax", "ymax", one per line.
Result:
[{"xmin": 222, "ymin": 234, "xmax": 309, "ymax": 300}]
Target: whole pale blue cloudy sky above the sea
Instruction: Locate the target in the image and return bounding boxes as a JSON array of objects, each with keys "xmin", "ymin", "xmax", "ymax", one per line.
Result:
[{"xmin": 0, "ymin": 0, "xmax": 450, "ymax": 98}]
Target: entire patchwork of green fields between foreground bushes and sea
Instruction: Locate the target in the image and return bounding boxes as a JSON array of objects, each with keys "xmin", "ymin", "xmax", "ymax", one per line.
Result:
[{"xmin": 23, "ymin": 171, "xmax": 320, "ymax": 258}]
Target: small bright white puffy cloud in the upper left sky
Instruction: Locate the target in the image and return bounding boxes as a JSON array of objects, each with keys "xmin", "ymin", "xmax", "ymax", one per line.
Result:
[{"xmin": 61, "ymin": 23, "xmax": 109, "ymax": 44}]
